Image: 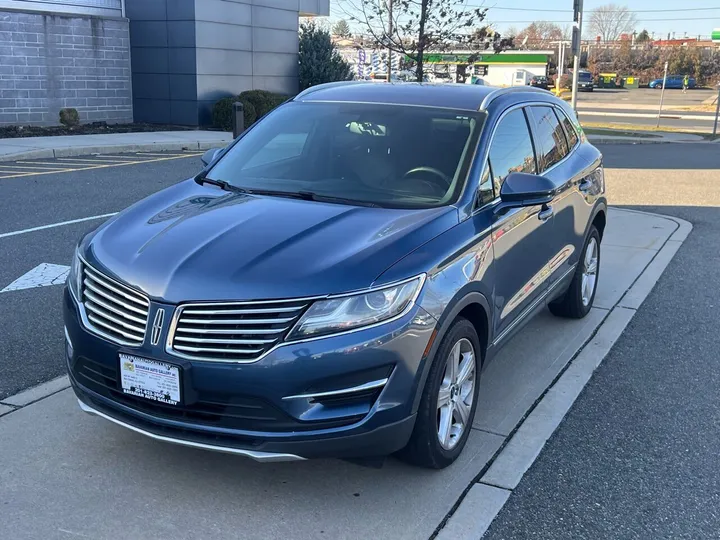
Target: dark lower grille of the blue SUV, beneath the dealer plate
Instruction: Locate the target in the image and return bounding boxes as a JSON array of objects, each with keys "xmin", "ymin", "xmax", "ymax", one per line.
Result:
[{"xmin": 72, "ymin": 357, "xmax": 362, "ymax": 432}]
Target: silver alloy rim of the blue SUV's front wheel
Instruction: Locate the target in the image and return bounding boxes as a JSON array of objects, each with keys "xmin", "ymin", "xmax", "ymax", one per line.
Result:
[{"xmin": 437, "ymin": 338, "xmax": 477, "ymax": 450}]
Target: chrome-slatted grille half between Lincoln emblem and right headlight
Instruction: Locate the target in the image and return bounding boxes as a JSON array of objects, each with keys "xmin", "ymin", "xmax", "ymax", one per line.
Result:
[{"xmin": 170, "ymin": 300, "xmax": 310, "ymax": 362}]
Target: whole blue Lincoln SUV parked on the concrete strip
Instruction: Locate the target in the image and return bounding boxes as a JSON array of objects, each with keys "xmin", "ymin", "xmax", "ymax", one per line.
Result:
[{"xmin": 64, "ymin": 83, "xmax": 607, "ymax": 468}]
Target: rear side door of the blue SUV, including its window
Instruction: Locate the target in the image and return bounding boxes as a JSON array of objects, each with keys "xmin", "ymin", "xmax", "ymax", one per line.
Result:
[{"xmin": 527, "ymin": 104, "xmax": 589, "ymax": 287}]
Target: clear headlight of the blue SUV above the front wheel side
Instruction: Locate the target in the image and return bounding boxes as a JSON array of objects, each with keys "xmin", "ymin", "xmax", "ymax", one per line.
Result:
[{"xmin": 287, "ymin": 274, "xmax": 425, "ymax": 340}]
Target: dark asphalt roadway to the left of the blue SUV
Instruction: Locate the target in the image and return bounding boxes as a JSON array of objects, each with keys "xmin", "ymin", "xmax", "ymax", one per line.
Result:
[{"xmin": 0, "ymin": 152, "xmax": 202, "ymax": 399}]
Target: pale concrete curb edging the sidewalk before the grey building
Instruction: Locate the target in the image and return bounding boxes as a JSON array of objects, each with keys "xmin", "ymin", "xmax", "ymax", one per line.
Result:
[{"xmin": 0, "ymin": 139, "xmax": 228, "ymax": 162}]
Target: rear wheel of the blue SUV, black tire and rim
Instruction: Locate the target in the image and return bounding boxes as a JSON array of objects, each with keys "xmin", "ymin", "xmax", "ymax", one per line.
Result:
[{"xmin": 549, "ymin": 225, "xmax": 600, "ymax": 319}]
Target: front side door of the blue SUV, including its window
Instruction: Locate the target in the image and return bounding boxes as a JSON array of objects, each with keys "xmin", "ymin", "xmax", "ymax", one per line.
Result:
[{"xmin": 486, "ymin": 108, "xmax": 554, "ymax": 343}]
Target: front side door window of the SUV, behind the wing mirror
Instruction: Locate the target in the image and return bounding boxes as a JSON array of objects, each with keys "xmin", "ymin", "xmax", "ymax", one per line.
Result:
[{"xmin": 490, "ymin": 109, "xmax": 536, "ymax": 194}]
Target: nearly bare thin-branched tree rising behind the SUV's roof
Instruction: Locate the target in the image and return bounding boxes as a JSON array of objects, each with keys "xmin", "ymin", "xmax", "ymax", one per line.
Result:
[{"xmin": 341, "ymin": 0, "xmax": 487, "ymax": 82}]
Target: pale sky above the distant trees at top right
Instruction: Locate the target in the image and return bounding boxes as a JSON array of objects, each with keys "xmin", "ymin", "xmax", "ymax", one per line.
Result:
[{"xmin": 330, "ymin": 0, "xmax": 720, "ymax": 39}]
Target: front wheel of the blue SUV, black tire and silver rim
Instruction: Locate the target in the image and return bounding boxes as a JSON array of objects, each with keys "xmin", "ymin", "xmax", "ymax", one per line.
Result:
[{"xmin": 398, "ymin": 318, "xmax": 483, "ymax": 469}]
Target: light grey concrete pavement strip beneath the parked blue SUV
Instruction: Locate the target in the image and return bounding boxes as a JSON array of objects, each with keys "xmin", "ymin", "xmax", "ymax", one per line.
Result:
[{"xmin": 0, "ymin": 209, "xmax": 690, "ymax": 540}]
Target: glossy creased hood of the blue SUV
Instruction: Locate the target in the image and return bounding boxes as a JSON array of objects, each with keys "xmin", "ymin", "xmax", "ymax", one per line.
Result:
[{"xmin": 81, "ymin": 180, "xmax": 458, "ymax": 303}]
